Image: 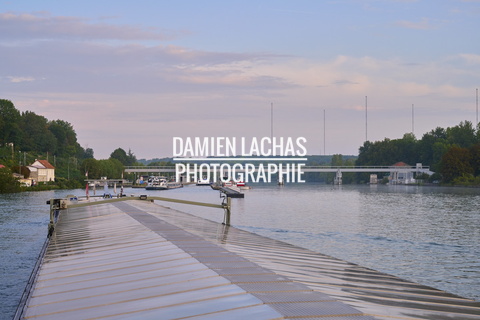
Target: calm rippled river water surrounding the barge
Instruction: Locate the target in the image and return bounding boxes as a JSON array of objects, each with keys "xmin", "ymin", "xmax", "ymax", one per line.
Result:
[{"xmin": 0, "ymin": 183, "xmax": 480, "ymax": 319}]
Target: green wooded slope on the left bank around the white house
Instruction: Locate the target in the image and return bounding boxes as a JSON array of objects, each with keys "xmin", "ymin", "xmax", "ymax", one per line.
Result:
[{"xmin": 0, "ymin": 99, "xmax": 142, "ymax": 193}]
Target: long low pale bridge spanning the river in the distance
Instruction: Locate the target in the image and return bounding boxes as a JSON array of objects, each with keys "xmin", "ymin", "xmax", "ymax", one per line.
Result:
[{"xmin": 125, "ymin": 163, "xmax": 434, "ymax": 184}]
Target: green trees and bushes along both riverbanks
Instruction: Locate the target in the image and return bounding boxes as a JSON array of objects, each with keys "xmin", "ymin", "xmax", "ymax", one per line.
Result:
[{"xmin": 0, "ymin": 99, "xmax": 480, "ymax": 193}]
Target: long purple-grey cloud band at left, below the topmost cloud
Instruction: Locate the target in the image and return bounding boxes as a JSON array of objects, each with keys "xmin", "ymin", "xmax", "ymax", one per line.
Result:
[{"xmin": 0, "ymin": 36, "xmax": 288, "ymax": 95}]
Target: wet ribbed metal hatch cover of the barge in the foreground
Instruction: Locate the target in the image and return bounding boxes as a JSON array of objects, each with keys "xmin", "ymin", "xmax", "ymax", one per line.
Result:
[{"xmin": 20, "ymin": 201, "xmax": 480, "ymax": 320}]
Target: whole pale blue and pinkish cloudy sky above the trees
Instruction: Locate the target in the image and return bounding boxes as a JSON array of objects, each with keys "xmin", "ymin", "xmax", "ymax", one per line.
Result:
[{"xmin": 0, "ymin": 0, "xmax": 480, "ymax": 159}]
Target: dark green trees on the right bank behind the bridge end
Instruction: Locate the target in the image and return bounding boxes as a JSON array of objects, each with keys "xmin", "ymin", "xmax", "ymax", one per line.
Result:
[{"xmin": 355, "ymin": 121, "xmax": 480, "ymax": 185}]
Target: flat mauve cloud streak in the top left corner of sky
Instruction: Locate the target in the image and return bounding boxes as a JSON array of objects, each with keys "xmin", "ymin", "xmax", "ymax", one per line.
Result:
[{"xmin": 0, "ymin": 13, "xmax": 178, "ymax": 41}]
